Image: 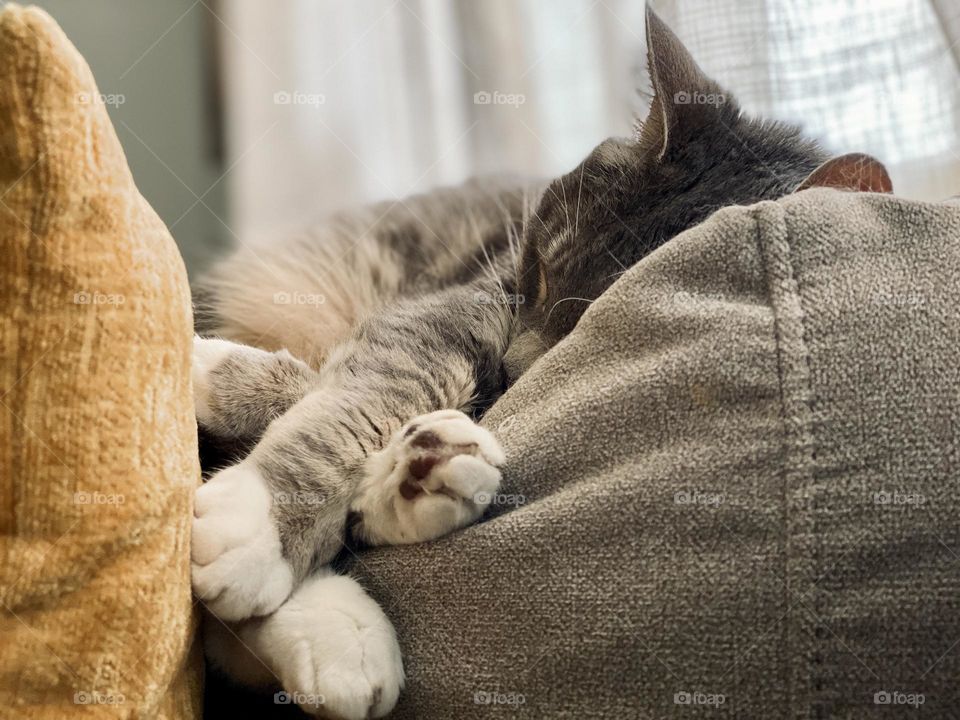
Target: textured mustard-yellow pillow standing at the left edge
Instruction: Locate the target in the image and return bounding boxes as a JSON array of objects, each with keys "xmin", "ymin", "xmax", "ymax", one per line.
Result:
[{"xmin": 0, "ymin": 6, "xmax": 202, "ymax": 719}]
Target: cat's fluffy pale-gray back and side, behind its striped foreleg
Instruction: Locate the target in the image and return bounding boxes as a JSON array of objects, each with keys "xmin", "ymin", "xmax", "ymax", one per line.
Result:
[{"xmin": 194, "ymin": 177, "xmax": 542, "ymax": 365}]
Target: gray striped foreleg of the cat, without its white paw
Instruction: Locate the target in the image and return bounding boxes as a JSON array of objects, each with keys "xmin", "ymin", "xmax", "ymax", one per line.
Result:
[{"xmin": 251, "ymin": 290, "xmax": 511, "ymax": 577}]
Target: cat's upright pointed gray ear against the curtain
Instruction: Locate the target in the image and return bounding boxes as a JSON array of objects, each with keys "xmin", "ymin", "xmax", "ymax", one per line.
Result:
[{"xmin": 637, "ymin": 3, "xmax": 735, "ymax": 160}]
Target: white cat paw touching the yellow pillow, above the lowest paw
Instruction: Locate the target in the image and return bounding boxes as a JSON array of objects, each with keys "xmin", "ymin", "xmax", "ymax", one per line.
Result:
[{"xmin": 191, "ymin": 463, "xmax": 293, "ymax": 620}]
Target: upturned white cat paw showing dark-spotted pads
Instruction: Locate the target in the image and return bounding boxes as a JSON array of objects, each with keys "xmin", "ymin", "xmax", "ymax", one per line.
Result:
[{"xmin": 351, "ymin": 410, "xmax": 504, "ymax": 545}]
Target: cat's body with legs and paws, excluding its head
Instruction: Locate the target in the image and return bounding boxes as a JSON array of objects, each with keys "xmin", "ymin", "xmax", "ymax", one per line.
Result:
[{"xmin": 194, "ymin": 180, "xmax": 538, "ymax": 717}]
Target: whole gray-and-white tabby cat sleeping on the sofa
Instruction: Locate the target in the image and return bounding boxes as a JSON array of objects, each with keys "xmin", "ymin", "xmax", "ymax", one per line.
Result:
[{"xmin": 192, "ymin": 9, "xmax": 885, "ymax": 718}]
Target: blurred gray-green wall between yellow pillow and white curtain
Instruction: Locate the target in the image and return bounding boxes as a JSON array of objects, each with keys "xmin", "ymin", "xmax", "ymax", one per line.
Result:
[{"xmin": 33, "ymin": 0, "xmax": 231, "ymax": 274}]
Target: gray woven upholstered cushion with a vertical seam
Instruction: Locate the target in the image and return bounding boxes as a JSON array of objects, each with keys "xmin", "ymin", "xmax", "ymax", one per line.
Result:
[{"xmin": 344, "ymin": 190, "xmax": 960, "ymax": 718}]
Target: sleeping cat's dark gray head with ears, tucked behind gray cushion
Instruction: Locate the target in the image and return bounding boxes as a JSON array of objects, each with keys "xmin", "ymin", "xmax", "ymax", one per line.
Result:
[{"xmin": 505, "ymin": 6, "xmax": 889, "ymax": 379}]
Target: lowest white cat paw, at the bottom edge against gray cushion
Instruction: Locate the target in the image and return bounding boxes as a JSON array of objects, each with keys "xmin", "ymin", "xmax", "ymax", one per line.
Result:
[{"xmin": 251, "ymin": 575, "xmax": 403, "ymax": 720}]
